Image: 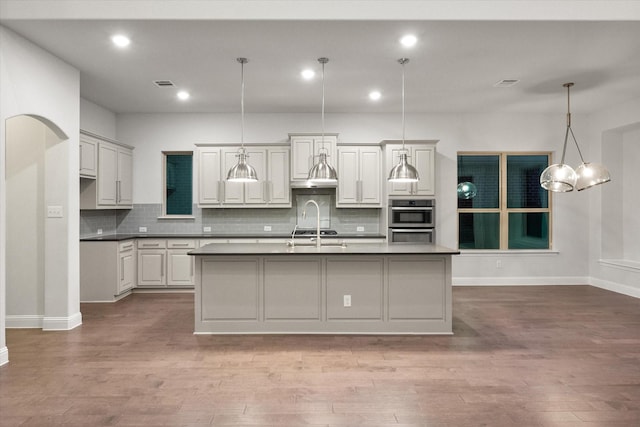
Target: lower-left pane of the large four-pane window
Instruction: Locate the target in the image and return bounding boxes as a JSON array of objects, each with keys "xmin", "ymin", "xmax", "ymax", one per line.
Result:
[{"xmin": 458, "ymin": 213, "xmax": 500, "ymax": 249}]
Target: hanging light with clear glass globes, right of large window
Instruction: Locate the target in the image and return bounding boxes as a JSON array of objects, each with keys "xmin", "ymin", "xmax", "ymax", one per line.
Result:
[{"xmin": 540, "ymin": 83, "xmax": 611, "ymax": 193}]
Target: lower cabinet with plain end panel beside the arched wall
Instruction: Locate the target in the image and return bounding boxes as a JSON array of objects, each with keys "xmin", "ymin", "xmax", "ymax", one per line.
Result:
[{"xmin": 80, "ymin": 239, "xmax": 136, "ymax": 302}]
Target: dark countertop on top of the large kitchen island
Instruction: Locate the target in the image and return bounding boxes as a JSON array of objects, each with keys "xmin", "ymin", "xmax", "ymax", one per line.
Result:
[{"xmin": 189, "ymin": 242, "xmax": 460, "ymax": 256}]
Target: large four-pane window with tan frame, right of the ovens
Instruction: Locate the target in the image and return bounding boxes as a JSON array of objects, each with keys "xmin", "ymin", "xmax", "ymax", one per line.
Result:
[{"xmin": 458, "ymin": 153, "xmax": 551, "ymax": 250}]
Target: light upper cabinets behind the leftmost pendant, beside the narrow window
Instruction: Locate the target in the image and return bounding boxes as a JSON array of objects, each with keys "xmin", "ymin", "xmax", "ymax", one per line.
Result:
[{"xmin": 197, "ymin": 146, "xmax": 291, "ymax": 208}]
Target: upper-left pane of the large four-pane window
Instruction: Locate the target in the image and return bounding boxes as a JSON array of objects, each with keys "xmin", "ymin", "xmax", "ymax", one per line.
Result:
[{"xmin": 458, "ymin": 155, "xmax": 500, "ymax": 208}]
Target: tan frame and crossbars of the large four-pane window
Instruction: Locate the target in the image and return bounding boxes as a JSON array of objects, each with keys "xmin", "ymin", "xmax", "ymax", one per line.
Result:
[{"xmin": 456, "ymin": 151, "xmax": 553, "ymax": 252}]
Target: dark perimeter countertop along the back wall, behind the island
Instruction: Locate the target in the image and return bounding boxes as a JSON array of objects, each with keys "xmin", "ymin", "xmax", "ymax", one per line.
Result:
[{"xmin": 80, "ymin": 233, "xmax": 386, "ymax": 242}]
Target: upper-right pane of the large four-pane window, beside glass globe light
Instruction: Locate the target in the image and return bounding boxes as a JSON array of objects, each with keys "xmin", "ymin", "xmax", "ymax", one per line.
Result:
[{"xmin": 507, "ymin": 155, "xmax": 549, "ymax": 208}]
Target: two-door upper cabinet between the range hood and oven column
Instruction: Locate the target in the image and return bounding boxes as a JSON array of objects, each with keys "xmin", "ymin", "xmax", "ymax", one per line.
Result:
[{"xmin": 336, "ymin": 146, "xmax": 383, "ymax": 208}]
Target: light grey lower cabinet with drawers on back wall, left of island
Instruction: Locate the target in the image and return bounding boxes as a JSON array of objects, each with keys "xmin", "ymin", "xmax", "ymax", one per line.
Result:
[{"xmin": 138, "ymin": 239, "xmax": 195, "ymax": 288}]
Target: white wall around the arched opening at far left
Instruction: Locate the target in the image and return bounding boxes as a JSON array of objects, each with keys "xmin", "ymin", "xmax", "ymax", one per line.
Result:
[{"xmin": 0, "ymin": 26, "xmax": 81, "ymax": 364}]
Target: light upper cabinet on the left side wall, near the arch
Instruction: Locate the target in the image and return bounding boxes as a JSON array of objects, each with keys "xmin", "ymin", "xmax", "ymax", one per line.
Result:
[{"xmin": 80, "ymin": 134, "xmax": 133, "ymax": 209}]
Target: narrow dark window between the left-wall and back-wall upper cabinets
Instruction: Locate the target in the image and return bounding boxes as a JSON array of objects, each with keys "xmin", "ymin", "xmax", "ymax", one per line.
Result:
[{"xmin": 162, "ymin": 151, "xmax": 193, "ymax": 216}]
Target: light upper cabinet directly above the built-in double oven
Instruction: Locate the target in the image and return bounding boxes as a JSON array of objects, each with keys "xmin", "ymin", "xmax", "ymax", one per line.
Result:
[{"xmin": 385, "ymin": 141, "xmax": 437, "ymax": 196}]
